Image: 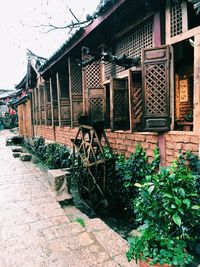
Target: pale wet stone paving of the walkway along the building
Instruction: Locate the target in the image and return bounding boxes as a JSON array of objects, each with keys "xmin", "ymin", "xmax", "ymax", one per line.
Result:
[{"xmin": 0, "ymin": 130, "xmax": 137, "ymax": 267}]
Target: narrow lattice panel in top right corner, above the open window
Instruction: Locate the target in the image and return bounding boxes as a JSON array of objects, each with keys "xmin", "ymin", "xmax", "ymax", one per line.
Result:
[{"xmin": 170, "ymin": 1, "xmax": 183, "ymax": 37}]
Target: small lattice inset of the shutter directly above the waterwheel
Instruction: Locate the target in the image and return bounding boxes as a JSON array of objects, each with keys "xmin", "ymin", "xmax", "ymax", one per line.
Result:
[{"xmin": 90, "ymin": 97, "xmax": 104, "ymax": 122}]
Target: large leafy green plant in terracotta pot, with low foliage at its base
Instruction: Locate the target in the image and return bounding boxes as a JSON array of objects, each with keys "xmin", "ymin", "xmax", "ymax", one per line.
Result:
[{"xmin": 126, "ymin": 156, "xmax": 200, "ymax": 267}]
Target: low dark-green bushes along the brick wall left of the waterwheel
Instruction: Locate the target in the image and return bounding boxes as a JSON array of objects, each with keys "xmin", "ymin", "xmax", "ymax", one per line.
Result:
[{"xmin": 33, "ymin": 137, "xmax": 72, "ymax": 169}]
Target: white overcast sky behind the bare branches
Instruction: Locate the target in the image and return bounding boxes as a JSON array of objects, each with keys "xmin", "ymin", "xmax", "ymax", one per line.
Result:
[{"xmin": 0, "ymin": 0, "xmax": 100, "ymax": 89}]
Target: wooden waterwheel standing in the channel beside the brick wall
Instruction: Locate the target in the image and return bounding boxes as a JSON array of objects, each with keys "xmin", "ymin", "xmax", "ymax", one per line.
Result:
[{"xmin": 71, "ymin": 122, "xmax": 115, "ymax": 210}]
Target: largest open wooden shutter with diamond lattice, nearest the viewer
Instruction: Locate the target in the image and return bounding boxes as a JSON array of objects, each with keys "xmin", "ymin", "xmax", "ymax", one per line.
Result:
[{"xmin": 142, "ymin": 46, "xmax": 170, "ymax": 132}]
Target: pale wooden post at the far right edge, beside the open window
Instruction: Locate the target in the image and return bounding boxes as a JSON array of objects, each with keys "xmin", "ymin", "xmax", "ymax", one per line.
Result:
[{"xmin": 193, "ymin": 33, "xmax": 200, "ymax": 133}]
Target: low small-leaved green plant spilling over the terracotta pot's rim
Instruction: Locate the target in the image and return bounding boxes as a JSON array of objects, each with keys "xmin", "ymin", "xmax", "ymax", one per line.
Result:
[{"xmin": 126, "ymin": 228, "xmax": 193, "ymax": 266}]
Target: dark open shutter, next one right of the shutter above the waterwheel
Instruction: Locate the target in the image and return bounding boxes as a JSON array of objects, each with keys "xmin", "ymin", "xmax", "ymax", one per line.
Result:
[{"xmin": 110, "ymin": 78, "xmax": 129, "ymax": 130}]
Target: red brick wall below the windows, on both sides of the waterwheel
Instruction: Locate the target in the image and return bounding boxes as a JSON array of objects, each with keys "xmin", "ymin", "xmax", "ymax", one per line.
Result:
[{"xmin": 36, "ymin": 125, "xmax": 199, "ymax": 166}]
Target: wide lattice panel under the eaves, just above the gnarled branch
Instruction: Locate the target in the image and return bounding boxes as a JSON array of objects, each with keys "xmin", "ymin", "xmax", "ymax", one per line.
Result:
[{"xmin": 115, "ymin": 20, "xmax": 153, "ymax": 73}]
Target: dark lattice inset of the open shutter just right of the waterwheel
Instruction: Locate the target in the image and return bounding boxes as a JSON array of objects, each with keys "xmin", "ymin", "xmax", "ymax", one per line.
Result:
[{"xmin": 114, "ymin": 91, "xmax": 127, "ymax": 120}]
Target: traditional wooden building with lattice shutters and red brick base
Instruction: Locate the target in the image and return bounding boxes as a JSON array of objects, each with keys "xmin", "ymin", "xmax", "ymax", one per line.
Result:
[{"xmin": 18, "ymin": 0, "xmax": 200, "ymax": 165}]
